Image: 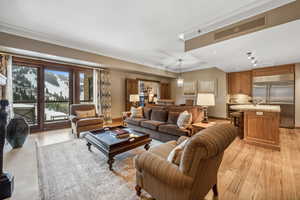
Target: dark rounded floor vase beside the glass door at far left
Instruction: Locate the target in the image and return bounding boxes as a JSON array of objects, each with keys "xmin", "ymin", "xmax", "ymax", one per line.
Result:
[{"xmin": 6, "ymin": 117, "xmax": 29, "ymax": 148}]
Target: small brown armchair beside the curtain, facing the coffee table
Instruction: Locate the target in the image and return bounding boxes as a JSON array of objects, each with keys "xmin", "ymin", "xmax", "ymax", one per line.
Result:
[{"xmin": 69, "ymin": 104, "xmax": 103, "ymax": 138}]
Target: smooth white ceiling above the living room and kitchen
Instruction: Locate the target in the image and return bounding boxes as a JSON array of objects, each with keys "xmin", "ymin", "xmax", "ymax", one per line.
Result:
[{"xmin": 0, "ymin": 0, "xmax": 300, "ymax": 71}]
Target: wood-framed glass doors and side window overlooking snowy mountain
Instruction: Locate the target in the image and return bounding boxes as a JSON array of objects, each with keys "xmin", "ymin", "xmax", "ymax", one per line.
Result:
[{"xmin": 12, "ymin": 58, "xmax": 93, "ymax": 132}]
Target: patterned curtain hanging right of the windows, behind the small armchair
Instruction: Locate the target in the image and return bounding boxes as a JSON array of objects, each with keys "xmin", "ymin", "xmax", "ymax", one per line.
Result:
[{"xmin": 94, "ymin": 69, "xmax": 112, "ymax": 124}]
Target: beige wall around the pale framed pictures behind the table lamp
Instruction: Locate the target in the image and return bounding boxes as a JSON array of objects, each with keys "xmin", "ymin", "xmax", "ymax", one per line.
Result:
[{"xmin": 171, "ymin": 68, "xmax": 227, "ymax": 118}]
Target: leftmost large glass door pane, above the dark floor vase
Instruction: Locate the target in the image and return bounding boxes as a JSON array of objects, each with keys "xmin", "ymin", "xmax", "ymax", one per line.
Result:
[{"xmin": 12, "ymin": 64, "xmax": 37, "ymax": 125}]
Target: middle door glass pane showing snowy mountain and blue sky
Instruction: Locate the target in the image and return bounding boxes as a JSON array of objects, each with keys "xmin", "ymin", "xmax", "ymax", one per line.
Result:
[{"xmin": 44, "ymin": 69, "xmax": 70, "ymax": 122}]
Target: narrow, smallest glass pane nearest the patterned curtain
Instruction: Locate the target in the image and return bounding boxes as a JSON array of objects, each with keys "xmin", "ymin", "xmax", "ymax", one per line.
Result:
[{"xmin": 79, "ymin": 71, "xmax": 93, "ymax": 103}]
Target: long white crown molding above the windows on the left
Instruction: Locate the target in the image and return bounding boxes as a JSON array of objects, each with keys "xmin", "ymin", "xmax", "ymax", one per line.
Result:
[{"xmin": 0, "ymin": 21, "xmax": 172, "ymax": 72}]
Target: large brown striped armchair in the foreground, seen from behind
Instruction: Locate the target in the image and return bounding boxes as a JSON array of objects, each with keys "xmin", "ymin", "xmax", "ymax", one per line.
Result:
[{"xmin": 135, "ymin": 124, "xmax": 237, "ymax": 200}]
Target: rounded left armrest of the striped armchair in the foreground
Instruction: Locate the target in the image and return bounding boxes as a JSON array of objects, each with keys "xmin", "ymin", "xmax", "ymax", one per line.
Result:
[{"xmin": 135, "ymin": 152, "xmax": 193, "ymax": 188}]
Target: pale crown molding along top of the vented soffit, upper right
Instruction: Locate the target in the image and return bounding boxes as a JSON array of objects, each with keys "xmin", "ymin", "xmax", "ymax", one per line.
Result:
[{"xmin": 183, "ymin": 0, "xmax": 296, "ymax": 41}]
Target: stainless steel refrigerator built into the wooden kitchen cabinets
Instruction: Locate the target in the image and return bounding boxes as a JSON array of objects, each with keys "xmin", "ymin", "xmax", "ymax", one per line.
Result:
[{"xmin": 253, "ymin": 73, "xmax": 295, "ymax": 128}]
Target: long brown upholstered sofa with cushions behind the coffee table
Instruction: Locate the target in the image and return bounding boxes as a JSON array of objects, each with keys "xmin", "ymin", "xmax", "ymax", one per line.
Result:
[{"xmin": 124, "ymin": 105, "xmax": 203, "ymax": 142}]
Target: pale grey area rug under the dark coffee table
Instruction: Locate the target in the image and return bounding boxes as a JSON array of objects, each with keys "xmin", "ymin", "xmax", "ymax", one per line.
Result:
[{"xmin": 37, "ymin": 139, "xmax": 155, "ymax": 200}]
